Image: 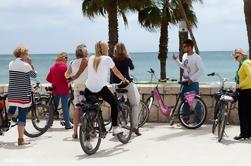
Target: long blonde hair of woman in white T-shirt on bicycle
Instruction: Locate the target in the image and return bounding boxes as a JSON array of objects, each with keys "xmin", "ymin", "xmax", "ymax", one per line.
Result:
[{"xmin": 93, "ymin": 41, "xmax": 108, "ymax": 71}]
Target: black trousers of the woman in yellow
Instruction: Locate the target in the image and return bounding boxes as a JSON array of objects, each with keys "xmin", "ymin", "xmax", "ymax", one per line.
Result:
[{"xmin": 238, "ymin": 89, "xmax": 251, "ymax": 137}]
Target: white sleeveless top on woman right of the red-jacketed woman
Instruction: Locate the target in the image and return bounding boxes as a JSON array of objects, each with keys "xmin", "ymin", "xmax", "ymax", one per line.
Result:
[{"xmin": 70, "ymin": 58, "xmax": 88, "ymax": 90}]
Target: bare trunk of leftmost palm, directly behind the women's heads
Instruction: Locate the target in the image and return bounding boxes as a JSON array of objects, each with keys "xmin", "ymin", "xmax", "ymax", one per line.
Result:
[{"xmin": 108, "ymin": 0, "xmax": 118, "ymax": 57}]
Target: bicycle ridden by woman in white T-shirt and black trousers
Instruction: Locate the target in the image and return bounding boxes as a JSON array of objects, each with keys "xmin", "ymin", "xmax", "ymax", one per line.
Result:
[{"xmin": 77, "ymin": 82, "xmax": 132, "ymax": 155}]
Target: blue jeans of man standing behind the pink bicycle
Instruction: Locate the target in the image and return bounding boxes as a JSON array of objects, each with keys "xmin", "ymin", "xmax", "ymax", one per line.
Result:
[{"xmin": 181, "ymin": 82, "xmax": 201, "ymax": 124}]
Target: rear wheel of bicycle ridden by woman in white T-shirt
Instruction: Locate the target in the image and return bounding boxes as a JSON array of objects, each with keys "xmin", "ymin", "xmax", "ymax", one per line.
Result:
[{"xmin": 79, "ymin": 114, "xmax": 102, "ymax": 155}]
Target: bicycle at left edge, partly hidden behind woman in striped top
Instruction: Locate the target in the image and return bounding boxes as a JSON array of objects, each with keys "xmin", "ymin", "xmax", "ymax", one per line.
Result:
[{"xmin": 0, "ymin": 82, "xmax": 52, "ymax": 138}]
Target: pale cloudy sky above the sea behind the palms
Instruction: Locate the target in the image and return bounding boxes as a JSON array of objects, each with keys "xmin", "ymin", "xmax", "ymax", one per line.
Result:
[{"xmin": 0, "ymin": 0, "xmax": 248, "ymax": 54}]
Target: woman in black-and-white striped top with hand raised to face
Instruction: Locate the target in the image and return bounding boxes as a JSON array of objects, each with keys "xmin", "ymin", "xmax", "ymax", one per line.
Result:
[{"xmin": 8, "ymin": 46, "xmax": 37, "ymax": 145}]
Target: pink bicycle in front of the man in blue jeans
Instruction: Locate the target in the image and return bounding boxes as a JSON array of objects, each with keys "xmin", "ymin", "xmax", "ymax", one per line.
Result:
[{"xmin": 140, "ymin": 68, "xmax": 207, "ymax": 129}]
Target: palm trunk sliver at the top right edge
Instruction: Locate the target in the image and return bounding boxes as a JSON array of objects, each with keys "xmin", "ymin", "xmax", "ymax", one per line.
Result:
[{"xmin": 244, "ymin": 0, "xmax": 251, "ymax": 59}]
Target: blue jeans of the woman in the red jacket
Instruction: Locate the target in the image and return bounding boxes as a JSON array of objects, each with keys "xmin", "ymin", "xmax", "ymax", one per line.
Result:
[{"xmin": 53, "ymin": 94, "xmax": 71, "ymax": 128}]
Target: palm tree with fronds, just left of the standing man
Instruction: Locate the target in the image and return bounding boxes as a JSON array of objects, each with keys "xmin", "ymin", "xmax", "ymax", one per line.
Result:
[{"xmin": 138, "ymin": 0, "xmax": 175, "ymax": 80}]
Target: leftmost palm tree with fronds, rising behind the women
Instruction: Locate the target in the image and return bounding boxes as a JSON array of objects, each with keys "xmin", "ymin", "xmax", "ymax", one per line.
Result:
[{"xmin": 82, "ymin": 0, "xmax": 151, "ymax": 56}]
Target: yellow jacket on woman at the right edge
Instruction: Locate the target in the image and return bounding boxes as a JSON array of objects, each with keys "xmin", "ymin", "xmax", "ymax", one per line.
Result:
[{"xmin": 238, "ymin": 59, "xmax": 251, "ymax": 89}]
